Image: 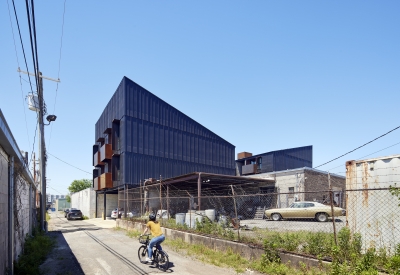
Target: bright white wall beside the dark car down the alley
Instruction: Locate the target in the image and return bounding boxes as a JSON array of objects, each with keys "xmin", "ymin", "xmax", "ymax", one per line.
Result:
[{"xmin": 71, "ymin": 187, "xmax": 96, "ymax": 219}]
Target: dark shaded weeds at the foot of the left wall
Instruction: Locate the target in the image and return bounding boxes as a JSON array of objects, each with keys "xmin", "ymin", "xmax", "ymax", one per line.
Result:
[{"xmin": 14, "ymin": 228, "xmax": 55, "ymax": 275}]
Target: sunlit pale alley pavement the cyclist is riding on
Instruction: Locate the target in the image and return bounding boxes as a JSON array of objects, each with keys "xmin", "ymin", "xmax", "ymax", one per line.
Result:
[{"xmin": 42, "ymin": 212, "xmax": 244, "ymax": 275}]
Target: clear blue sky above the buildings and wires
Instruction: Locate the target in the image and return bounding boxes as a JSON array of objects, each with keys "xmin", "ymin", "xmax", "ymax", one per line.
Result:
[{"xmin": 0, "ymin": 0, "xmax": 400, "ymax": 194}]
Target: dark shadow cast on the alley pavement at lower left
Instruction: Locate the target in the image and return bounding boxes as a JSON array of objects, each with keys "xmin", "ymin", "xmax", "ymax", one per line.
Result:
[{"xmin": 39, "ymin": 231, "xmax": 85, "ymax": 275}]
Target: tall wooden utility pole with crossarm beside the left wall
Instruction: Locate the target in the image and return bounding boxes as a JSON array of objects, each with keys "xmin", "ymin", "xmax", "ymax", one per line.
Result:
[{"xmin": 18, "ymin": 68, "xmax": 60, "ymax": 231}]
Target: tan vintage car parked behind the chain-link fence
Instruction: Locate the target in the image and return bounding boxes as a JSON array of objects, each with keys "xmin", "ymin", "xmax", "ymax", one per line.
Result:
[{"xmin": 265, "ymin": 201, "xmax": 346, "ymax": 222}]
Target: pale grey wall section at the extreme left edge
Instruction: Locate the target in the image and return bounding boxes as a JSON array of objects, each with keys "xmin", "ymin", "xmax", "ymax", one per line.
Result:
[{"xmin": 0, "ymin": 146, "xmax": 8, "ymax": 273}]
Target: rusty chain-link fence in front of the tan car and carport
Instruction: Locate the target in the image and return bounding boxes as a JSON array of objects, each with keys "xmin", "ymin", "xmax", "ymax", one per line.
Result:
[{"xmin": 118, "ymin": 166, "xmax": 400, "ymax": 253}]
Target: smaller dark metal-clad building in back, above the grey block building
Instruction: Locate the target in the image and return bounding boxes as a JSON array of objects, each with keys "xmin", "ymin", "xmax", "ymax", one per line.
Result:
[{"xmin": 236, "ymin": 146, "xmax": 312, "ymax": 176}]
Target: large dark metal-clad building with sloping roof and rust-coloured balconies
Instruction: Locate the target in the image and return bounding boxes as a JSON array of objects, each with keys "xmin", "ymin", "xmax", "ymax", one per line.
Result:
[{"xmin": 93, "ymin": 77, "xmax": 235, "ymax": 190}]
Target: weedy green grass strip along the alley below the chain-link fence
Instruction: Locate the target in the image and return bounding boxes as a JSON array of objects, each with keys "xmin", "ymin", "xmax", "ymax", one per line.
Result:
[{"xmin": 118, "ymin": 219, "xmax": 400, "ymax": 275}]
